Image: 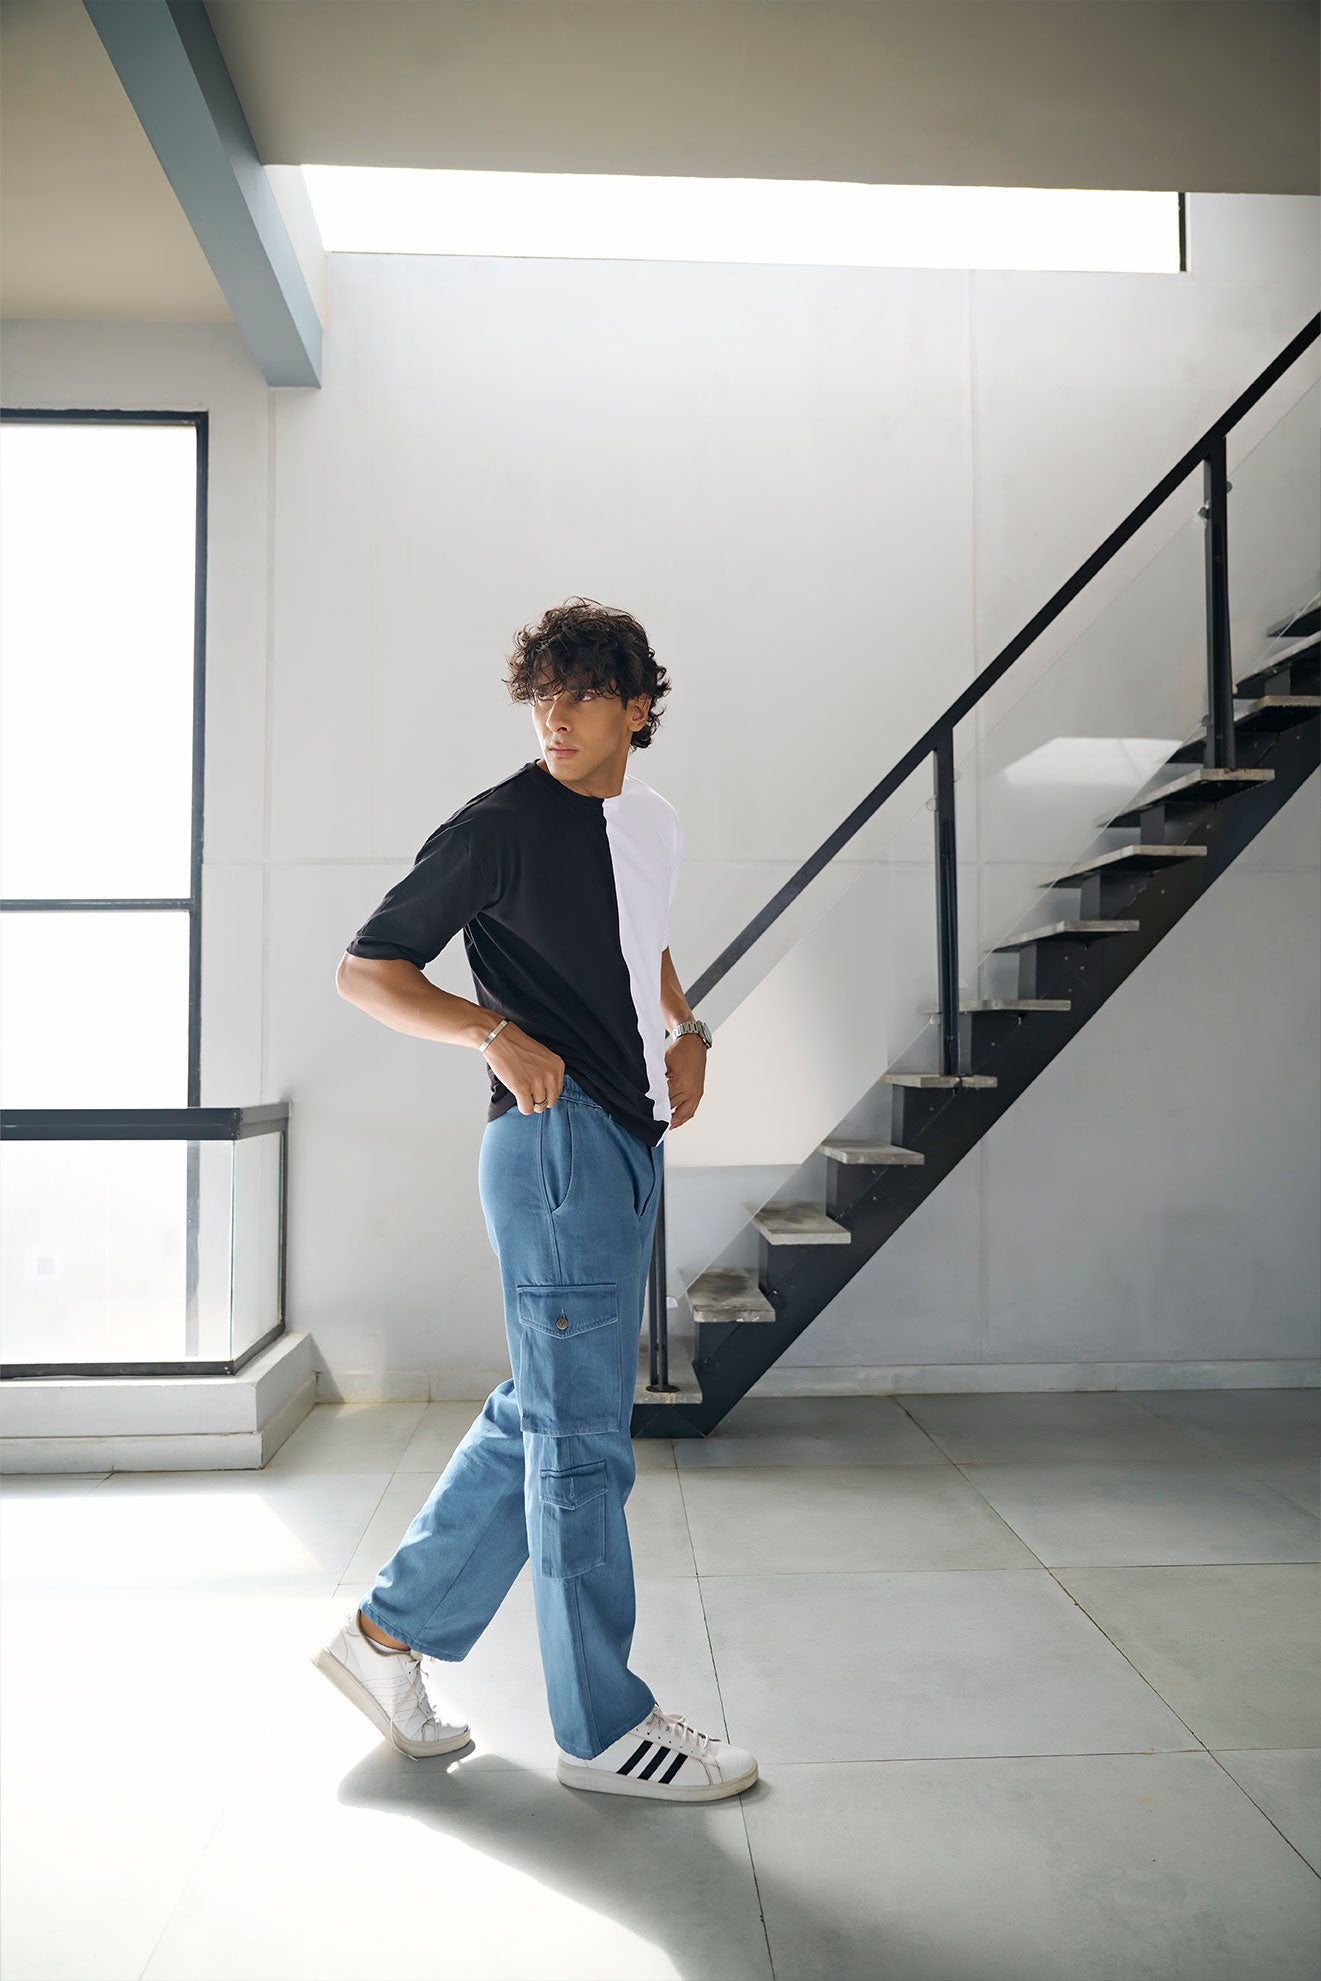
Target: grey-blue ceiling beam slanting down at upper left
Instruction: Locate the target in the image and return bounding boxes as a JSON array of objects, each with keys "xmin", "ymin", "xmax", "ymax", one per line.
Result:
[{"xmin": 83, "ymin": 0, "xmax": 321, "ymax": 384}]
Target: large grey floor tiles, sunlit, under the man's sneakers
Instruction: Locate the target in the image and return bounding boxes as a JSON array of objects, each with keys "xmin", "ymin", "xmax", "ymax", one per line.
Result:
[{"xmin": 0, "ymin": 1391, "xmax": 1321, "ymax": 1981}]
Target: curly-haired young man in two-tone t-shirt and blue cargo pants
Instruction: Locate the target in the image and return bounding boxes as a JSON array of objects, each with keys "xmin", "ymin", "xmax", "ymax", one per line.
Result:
[{"xmin": 313, "ymin": 598, "xmax": 757, "ymax": 1801}]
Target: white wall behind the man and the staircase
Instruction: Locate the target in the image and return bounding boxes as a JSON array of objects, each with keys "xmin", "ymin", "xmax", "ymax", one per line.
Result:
[{"xmin": 4, "ymin": 196, "xmax": 1317, "ymax": 1395}]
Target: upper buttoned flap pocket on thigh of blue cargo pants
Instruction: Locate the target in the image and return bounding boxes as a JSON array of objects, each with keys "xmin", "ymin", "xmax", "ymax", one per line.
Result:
[{"xmin": 515, "ymin": 1280, "xmax": 632, "ymax": 1438}]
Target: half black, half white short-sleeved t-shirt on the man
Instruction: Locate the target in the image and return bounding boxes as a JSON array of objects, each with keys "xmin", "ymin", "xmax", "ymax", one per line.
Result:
[{"xmin": 349, "ymin": 757, "xmax": 683, "ymax": 1147}]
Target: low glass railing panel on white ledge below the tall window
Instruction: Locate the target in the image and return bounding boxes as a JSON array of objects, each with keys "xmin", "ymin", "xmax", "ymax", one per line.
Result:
[{"xmin": 0, "ymin": 1109, "xmax": 287, "ymax": 1375}]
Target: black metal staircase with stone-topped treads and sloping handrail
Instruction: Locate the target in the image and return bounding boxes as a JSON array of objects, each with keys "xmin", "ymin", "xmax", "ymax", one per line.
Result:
[{"xmin": 632, "ymin": 319, "xmax": 1321, "ymax": 1438}]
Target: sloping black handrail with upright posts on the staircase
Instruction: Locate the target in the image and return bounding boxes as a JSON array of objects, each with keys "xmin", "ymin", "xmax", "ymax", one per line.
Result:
[{"xmin": 648, "ymin": 313, "xmax": 1321, "ymax": 1395}]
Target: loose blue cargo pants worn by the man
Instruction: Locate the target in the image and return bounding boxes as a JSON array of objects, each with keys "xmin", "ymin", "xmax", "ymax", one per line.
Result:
[{"xmin": 360, "ymin": 1074, "xmax": 663, "ymax": 1759}]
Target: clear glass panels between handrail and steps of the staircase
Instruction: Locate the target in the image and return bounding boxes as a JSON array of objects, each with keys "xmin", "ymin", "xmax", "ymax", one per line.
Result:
[{"xmin": 665, "ymin": 372, "xmax": 1321, "ymax": 1296}]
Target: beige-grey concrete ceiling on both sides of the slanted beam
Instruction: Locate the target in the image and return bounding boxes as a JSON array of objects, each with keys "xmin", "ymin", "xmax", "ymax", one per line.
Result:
[{"xmin": 0, "ymin": 0, "xmax": 1321, "ymax": 323}]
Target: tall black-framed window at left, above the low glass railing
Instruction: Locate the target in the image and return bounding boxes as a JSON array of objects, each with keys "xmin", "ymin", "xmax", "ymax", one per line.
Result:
[{"xmin": 0, "ymin": 412, "xmax": 206, "ymax": 1107}]
